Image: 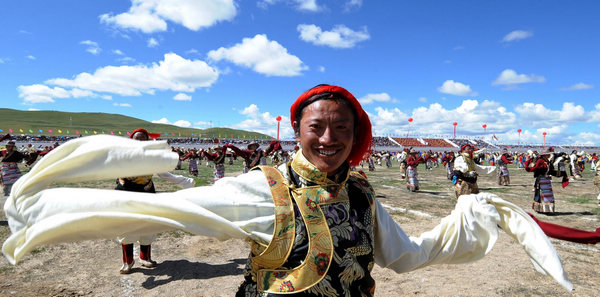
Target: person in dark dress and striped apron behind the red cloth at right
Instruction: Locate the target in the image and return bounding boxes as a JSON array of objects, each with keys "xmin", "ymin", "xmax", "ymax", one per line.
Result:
[{"xmin": 525, "ymin": 148, "xmax": 554, "ymax": 213}]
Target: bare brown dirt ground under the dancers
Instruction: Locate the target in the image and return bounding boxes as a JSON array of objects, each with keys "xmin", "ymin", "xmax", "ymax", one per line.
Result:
[{"xmin": 0, "ymin": 164, "xmax": 600, "ymax": 296}]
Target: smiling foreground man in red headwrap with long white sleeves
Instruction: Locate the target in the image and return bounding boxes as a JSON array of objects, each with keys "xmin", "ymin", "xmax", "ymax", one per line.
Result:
[{"xmin": 3, "ymin": 85, "xmax": 572, "ymax": 296}]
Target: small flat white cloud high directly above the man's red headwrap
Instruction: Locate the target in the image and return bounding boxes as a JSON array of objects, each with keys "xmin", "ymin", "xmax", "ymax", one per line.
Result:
[{"xmin": 297, "ymin": 24, "xmax": 371, "ymax": 48}]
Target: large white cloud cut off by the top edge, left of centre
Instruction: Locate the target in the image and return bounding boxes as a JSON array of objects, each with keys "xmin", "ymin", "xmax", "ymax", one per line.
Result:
[{"xmin": 100, "ymin": 0, "xmax": 237, "ymax": 33}]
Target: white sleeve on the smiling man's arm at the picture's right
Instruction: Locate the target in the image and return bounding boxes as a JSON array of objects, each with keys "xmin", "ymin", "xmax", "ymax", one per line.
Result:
[{"xmin": 375, "ymin": 193, "xmax": 573, "ymax": 291}]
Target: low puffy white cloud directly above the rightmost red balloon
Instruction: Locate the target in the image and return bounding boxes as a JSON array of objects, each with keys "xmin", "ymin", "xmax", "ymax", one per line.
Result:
[{"xmin": 515, "ymin": 102, "xmax": 585, "ymax": 122}]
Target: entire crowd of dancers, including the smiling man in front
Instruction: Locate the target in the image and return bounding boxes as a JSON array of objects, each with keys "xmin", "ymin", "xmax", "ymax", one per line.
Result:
[{"xmin": 2, "ymin": 85, "xmax": 600, "ymax": 296}]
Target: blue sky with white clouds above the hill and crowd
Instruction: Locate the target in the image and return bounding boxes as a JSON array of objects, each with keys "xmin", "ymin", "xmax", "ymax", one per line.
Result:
[{"xmin": 0, "ymin": 0, "xmax": 600, "ymax": 145}]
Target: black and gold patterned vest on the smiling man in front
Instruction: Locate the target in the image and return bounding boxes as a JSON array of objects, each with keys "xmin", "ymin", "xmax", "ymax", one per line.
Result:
[{"xmin": 236, "ymin": 151, "xmax": 375, "ymax": 296}]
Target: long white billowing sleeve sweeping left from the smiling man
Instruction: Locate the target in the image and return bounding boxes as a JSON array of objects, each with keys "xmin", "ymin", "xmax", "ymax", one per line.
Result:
[{"xmin": 2, "ymin": 136, "xmax": 274, "ymax": 264}]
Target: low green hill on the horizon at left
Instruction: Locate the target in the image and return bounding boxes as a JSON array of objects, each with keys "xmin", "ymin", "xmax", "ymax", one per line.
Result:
[{"xmin": 0, "ymin": 108, "xmax": 272, "ymax": 139}]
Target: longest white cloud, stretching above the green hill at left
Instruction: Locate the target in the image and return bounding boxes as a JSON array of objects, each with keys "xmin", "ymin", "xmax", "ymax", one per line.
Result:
[{"xmin": 46, "ymin": 53, "xmax": 219, "ymax": 96}]
